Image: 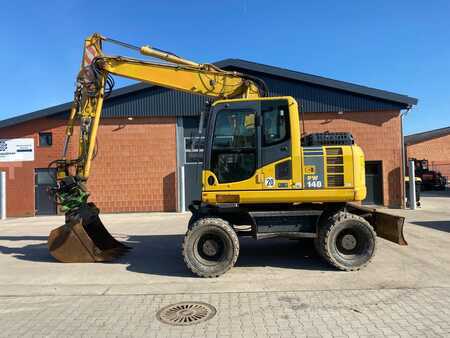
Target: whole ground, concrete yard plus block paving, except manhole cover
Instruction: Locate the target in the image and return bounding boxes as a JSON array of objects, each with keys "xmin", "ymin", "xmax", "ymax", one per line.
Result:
[{"xmin": 0, "ymin": 193, "xmax": 450, "ymax": 336}]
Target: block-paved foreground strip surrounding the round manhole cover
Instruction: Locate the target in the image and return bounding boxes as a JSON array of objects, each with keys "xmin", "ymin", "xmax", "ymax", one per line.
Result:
[{"xmin": 0, "ymin": 288, "xmax": 450, "ymax": 337}]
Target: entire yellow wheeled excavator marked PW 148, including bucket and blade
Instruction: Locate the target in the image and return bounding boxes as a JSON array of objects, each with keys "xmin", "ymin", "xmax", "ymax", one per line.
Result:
[{"xmin": 48, "ymin": 34, "xmax": 406, "ymax": 277}]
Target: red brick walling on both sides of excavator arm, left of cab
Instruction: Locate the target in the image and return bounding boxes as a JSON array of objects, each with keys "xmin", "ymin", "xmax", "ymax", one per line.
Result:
[{"xmin": 0, "ymin": 117, "xmax": 177, "ymax": 216}]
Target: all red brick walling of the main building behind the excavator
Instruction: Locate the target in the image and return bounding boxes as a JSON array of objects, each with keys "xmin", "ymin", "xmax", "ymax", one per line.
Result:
[{"xmin": 0, "ymin": 111, "xmax": 403, "ymax": 216}]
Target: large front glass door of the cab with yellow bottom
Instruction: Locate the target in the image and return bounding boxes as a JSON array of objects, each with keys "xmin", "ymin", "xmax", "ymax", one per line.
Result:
[{"xmin": 203, "ymin": 100, "xmax": 262, "ymax": 191}]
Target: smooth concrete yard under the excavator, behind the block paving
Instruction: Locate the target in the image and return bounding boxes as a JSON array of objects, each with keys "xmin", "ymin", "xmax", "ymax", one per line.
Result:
[{"xmin": 0, "ymin": 194, "xmax": 450, "ymax": 295}]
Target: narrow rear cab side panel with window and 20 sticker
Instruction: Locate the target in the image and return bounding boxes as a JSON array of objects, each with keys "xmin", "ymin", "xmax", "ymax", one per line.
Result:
[{"xmin": 258, "ymin": 99, "xmax": 292, "ymax": 190}]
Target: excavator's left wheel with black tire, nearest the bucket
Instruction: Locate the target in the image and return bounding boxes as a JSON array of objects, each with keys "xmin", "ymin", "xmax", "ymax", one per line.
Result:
[{"xmin": 183, "ymin": 217, "xmax": 239, "ymax": 278}]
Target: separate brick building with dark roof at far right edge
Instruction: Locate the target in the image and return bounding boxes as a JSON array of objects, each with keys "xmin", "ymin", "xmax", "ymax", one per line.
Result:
[{"xmin": 405, "ymin": 127, "xmax": 450, "ymax": 178}]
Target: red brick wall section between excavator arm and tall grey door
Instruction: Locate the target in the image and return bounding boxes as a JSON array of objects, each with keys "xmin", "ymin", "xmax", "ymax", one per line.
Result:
[{"xmin": 88, "ymin": 117, "xmax": 177, "ymax": 212}]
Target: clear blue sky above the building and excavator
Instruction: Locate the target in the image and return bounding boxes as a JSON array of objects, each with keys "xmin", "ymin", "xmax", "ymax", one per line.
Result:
[{"xmin": 0, "ymin": 0, "xmax": 450, "ymax": 134}]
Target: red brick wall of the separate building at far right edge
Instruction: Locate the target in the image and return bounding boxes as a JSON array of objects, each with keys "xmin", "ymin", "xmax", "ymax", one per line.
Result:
[{"xmin": 407, "ymin": 135, "xmax": 450, "ymax": 177}]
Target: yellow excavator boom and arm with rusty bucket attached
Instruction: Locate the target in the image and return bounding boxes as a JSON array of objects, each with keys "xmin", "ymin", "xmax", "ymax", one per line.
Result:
[{"xmin": 48, "ymin": 34, "xmax": 267, "ymax": 262}]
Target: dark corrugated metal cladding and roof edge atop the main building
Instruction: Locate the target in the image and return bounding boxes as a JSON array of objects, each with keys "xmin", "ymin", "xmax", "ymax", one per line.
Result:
[{"xmin": 0, "ymin": 59, "xmax": 417, "ymax": 128}]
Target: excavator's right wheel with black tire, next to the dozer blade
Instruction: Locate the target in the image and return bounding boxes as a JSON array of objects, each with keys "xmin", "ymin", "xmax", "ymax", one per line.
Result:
[{"xmin": 317, "ymin": 211, "xmax": 376, "ymax": 271}]
